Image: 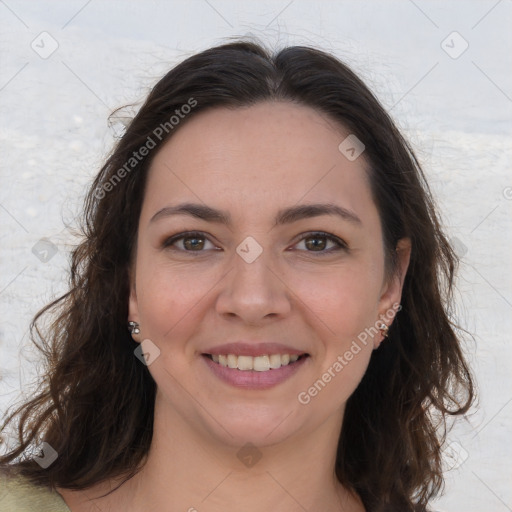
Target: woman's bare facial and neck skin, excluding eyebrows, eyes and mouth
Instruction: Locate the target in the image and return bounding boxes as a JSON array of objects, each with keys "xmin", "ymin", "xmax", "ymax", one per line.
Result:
[{"xmin": 60, "ymin": 102, "xmax": 410, "ymax": 512}]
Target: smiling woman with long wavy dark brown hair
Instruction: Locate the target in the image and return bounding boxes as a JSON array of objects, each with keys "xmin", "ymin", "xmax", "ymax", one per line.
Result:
[{"xmin": 0, "ymin": 42, "xmax": 473, "ymax": 512}]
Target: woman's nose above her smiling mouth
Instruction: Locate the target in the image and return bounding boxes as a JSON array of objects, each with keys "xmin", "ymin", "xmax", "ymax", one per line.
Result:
[{"xmin": 216, "ymin": 246, "xmax": 292, "ymax": 325}]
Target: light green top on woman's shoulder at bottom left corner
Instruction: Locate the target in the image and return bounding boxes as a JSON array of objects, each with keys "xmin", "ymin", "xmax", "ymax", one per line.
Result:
[{"xmin": 0, "ymin": 473, "xmax": 71, "ymax": 512}]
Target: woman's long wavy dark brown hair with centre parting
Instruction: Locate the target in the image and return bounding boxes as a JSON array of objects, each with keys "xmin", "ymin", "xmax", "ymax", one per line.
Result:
[{"xmin": 0, "ymin": 41, "xmax": 473, "ymax": 512}]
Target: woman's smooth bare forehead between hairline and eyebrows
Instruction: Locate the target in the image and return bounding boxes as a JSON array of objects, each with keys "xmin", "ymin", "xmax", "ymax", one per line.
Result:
[{"xmin": 142, "ymin": 102, "xmax": 375, "ymax": 225}]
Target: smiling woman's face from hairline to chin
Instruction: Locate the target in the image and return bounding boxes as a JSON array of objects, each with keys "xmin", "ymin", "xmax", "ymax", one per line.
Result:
[{"xmin": 129, "ymin": 102, "xmax": 408, "ymax": 446}]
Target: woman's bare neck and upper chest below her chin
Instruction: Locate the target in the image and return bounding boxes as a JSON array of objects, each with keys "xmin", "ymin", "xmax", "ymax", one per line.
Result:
[{"xmin": 62, "ymin": 399, "xmax": 364, "ymax": 512}]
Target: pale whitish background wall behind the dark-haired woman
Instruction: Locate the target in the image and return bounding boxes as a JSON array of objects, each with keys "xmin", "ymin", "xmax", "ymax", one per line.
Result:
[{"xmin": 0, "ymin": 0, "xmax": 512, "ymax": 512}]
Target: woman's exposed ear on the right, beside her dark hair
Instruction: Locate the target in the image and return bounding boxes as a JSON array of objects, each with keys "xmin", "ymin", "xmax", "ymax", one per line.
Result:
[{"xmin": 373, "ymin": 238, "xmax": 411, "ymax": 348}]
